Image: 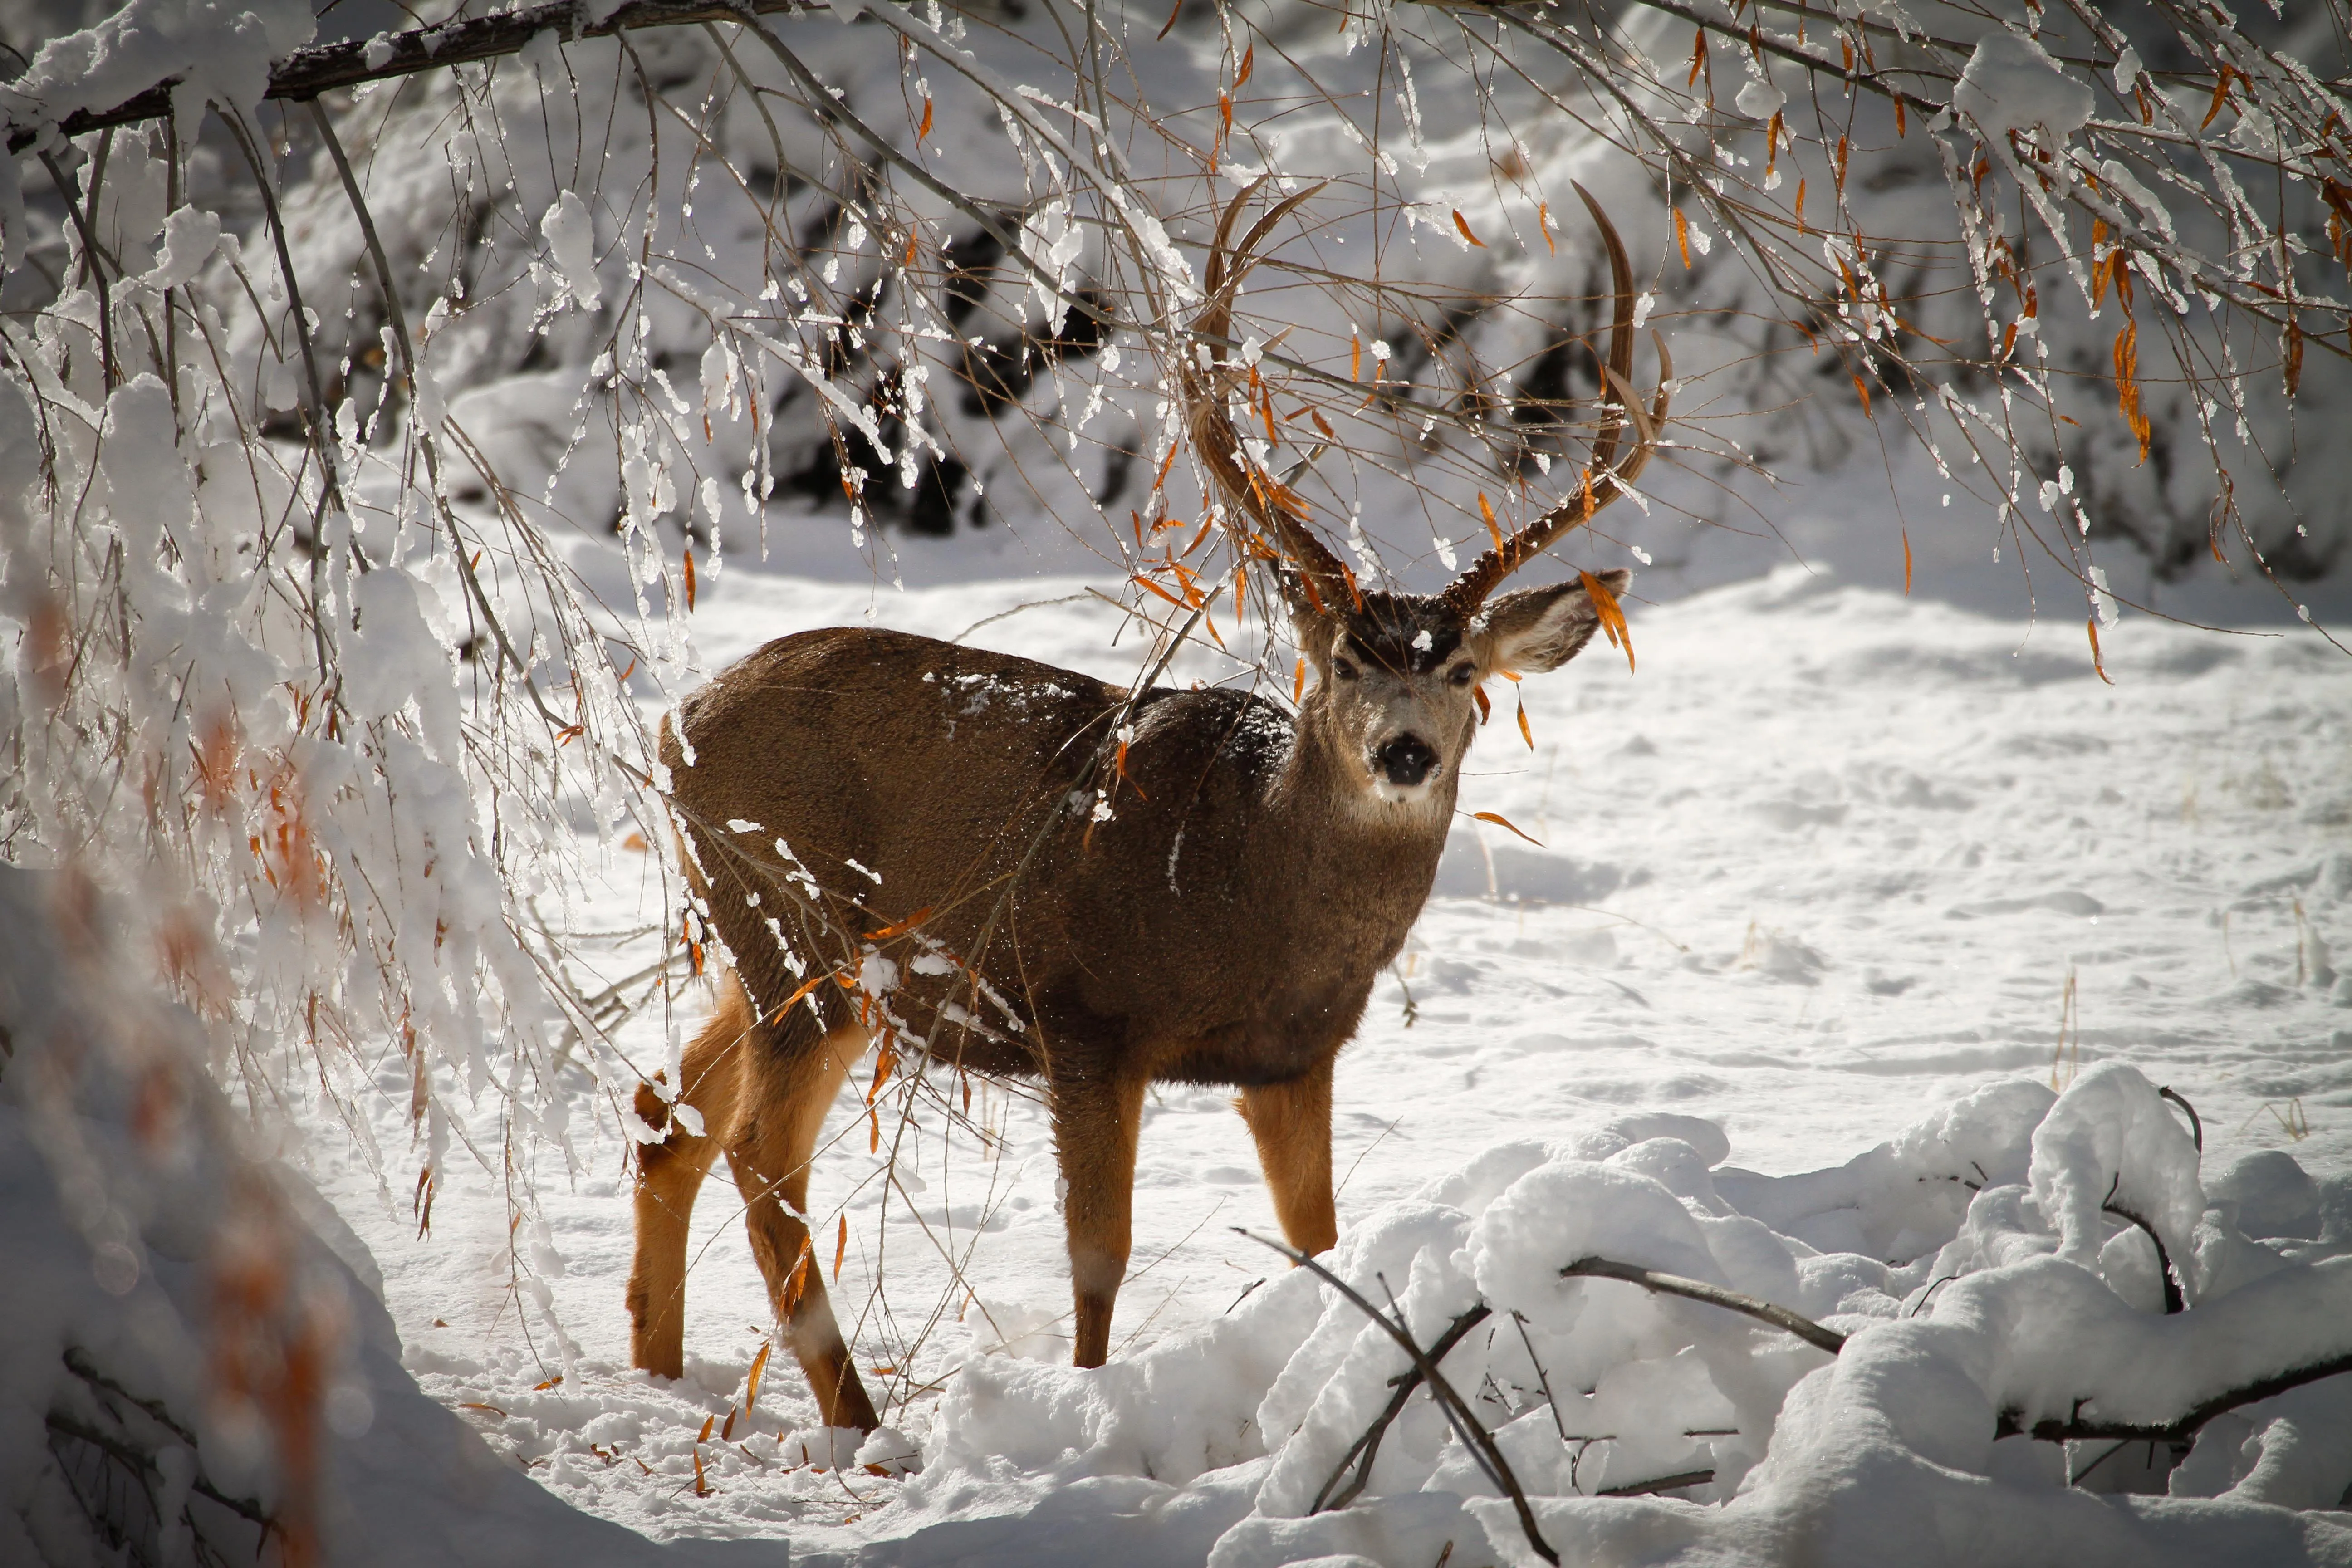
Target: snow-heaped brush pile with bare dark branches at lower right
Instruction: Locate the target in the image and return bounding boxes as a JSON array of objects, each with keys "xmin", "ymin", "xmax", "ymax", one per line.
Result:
[{"xmin": 908, "ymin": 1063, "xmax": 2352, "ymax": 1568}]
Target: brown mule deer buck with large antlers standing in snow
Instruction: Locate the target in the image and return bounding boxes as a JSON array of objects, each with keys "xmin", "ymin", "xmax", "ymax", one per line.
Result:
[{"xmin": 628, "ymin": 186, "xmax": 1672, "ymax": 1429}]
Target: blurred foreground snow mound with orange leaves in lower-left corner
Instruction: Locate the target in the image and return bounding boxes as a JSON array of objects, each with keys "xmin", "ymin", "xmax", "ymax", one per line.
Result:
[{"xmin": 0, "ymin": 865, "xmax": 652, "ymax": 1568}]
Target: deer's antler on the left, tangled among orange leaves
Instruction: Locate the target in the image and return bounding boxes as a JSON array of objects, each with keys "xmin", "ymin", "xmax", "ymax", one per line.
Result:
[{"xmin": 1176, "ymin": 176, "xmax": 1355, "ymax": 613}]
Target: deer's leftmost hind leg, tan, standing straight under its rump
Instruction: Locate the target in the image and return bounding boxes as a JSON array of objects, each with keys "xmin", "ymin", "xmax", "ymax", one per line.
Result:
[{"xmin": 628, "ymin": 975, "xmax": 750, "ymax": 1377}]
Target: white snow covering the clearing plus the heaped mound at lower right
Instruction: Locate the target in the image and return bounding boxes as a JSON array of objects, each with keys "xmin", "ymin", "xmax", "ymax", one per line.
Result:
[{"xmin": 270, "ymin": 557, "xmax": 2352, "ymax": 1568}]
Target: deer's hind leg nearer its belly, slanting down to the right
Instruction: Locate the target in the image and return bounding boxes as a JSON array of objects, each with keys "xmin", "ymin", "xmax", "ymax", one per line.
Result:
[{"xmin": 727, "ymin": 1009, "xmax": 882, "ymax": 1431}]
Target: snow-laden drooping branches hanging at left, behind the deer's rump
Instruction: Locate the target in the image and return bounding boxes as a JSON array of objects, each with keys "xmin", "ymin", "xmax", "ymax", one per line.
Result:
[{"xmin": 0, "ymin": 7, "xmax": 682, "ymax": 1307}]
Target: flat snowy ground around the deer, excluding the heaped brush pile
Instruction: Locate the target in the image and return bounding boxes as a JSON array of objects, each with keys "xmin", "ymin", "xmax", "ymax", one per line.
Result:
[{"xmin": 308, "ymin": 543, "xmax": 2352, "ymax": 1563}]
